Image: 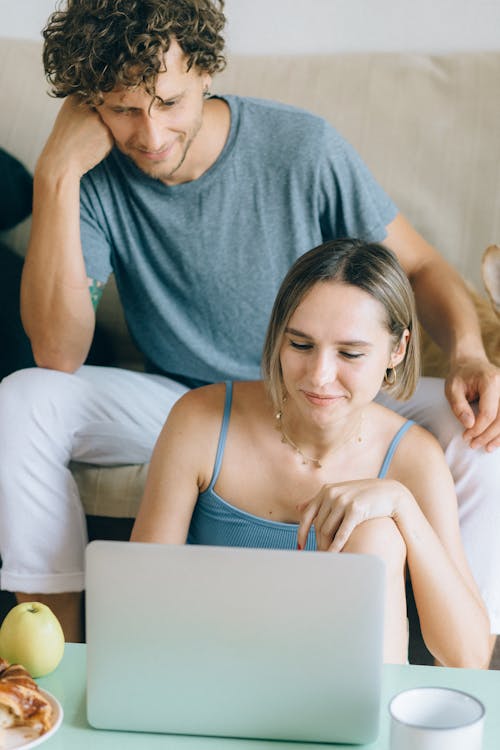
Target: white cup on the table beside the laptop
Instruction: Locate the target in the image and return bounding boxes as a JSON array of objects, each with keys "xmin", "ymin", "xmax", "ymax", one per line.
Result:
[{"xmin": 389, "ymin": 687, "xmax": 484, "ymax": 750}]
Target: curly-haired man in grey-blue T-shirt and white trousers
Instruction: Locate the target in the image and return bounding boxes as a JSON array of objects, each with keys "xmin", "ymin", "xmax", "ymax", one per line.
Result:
[{"xmin": 0, "ymin": 0, "xmax": 500, "ymax": 640}]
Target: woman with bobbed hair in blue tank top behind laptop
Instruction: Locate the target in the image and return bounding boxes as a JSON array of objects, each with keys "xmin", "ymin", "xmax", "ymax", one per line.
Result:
[{"xmin": 132, "ymin": 240, "xmax": 489, "ymax": 667}]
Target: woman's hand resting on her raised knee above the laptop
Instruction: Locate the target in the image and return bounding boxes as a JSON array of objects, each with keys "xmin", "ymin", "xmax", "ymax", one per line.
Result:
[{"xmin": 297, "ymin": 479, "xmax": 410, "ymax": 552}]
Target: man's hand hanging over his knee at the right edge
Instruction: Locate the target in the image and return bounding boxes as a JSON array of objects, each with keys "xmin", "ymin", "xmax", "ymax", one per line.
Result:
[{"xmin": 445, "ymin": 358, "xmax": 500, "ymax": 451}]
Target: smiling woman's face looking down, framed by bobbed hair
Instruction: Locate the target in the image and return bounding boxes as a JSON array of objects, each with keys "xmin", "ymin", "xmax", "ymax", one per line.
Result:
[{"xmin": 280, "ymin": 281, "xmax": 408, "ymax": 425}]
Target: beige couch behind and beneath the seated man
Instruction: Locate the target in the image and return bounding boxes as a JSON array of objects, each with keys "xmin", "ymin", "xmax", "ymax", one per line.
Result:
[{"xmin": 0, "ymin": 39, "xmax": 500, "ymax": 518}]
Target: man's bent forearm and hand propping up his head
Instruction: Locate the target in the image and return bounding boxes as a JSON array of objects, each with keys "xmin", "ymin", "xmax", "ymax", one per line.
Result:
[{"xmin": 21, "ymin": 97, "xmax": 113, "ymax": 372}]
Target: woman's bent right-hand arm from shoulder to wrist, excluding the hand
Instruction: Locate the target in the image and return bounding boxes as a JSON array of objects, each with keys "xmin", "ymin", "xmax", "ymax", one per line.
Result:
[{"xmin": 394, "ymin": 428, "xmax": 490, "ymax": 668}]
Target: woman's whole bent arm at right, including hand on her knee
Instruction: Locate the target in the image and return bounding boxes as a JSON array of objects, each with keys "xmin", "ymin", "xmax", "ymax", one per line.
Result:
[{"xmin": 298, "ymin": 427, "xmax": 490, "ymax": 668}]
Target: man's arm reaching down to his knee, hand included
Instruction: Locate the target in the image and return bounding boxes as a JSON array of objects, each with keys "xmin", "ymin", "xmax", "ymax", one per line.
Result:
[{"xmin": 384, "ymin": 215, "xmax": 500, "ymax": 450}]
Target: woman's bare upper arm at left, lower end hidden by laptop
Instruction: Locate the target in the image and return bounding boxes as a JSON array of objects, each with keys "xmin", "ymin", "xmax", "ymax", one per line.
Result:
[{"xmin": 130, "ymin": 386, "xmax": 224, "ymax": 544}]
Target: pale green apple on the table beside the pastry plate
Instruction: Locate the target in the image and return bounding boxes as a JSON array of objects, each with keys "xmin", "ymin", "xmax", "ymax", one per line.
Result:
[{"xmin": 0, "ymin": 602, "xmax": 64, "ymax": 677}]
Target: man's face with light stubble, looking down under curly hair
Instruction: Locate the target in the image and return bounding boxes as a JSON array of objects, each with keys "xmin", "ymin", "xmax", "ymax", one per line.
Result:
[{"xmin": 98, "ymin": 40, "xmax": 211, "ymax": 184}]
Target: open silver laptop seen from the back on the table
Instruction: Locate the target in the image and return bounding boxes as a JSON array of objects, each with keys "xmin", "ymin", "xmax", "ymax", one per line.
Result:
[{"xmin": 86, "ymin": 541, "xmax": 385, "ymax": 743}]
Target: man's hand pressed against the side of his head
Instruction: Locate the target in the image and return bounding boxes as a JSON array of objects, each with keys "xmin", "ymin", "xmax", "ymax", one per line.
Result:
[{"xmin": 37, "ymin": 96, "xmax": 113, "ymax": 179}]
